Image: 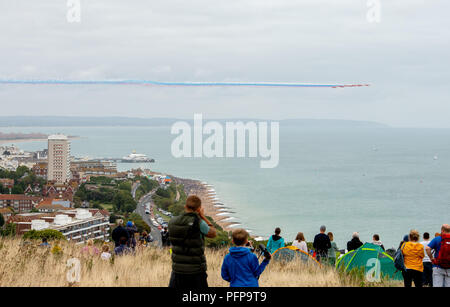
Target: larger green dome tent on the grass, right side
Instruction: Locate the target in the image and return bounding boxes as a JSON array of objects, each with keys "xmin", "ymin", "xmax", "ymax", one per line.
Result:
[{"xmin": 336, "ymin": 243, "xmax": 403, "ymax": 282}]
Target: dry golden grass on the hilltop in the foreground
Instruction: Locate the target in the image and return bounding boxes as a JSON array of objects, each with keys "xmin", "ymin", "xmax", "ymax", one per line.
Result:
[{"xmin": 0, "ymin": 238, "xmax": 399, "ymax": 287}]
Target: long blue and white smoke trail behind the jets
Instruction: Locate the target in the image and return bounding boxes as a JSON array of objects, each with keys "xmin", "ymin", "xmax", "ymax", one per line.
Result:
[{"xmin": 0, "ymin": 79, "xmax": 369, "ymax": 88}]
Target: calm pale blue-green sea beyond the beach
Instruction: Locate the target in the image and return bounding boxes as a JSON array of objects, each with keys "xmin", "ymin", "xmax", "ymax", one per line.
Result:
[{"xmin": 1, "ymin": 125, "xmax": 450, "ymax": 249}]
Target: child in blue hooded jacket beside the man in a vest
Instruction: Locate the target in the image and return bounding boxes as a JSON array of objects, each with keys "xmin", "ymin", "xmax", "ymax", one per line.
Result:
[{"xmin": 222, "ymin": 229, "xmax": 271, "ymax": 287}]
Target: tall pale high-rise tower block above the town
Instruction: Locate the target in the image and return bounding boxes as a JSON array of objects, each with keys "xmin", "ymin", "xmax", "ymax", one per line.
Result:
[{"xmin": 47, "ymin": 134, "xmax": 70, "ymax": 183}]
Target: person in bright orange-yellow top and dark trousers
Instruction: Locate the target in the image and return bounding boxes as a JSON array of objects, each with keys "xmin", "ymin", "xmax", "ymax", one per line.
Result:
[{"xmin": 402, "ymin": 230, "xmax": 425, "ymax": 288}]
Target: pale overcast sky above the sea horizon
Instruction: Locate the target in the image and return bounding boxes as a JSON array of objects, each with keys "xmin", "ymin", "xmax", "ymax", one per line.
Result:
[{"xmin": 0, "ymin": 0, "xmax": 450, "ymax": 128}]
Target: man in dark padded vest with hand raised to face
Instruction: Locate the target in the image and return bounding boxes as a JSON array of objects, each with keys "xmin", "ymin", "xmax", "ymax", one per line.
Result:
[{"xmin": 169, "ymin": 195, "xmax": 216, "ymax": 289}]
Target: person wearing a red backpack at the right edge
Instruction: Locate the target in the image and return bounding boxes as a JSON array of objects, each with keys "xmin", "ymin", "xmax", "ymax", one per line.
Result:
[{"xmin": 426, "ymin": 224, "xmax": 450, "ymax": 287}]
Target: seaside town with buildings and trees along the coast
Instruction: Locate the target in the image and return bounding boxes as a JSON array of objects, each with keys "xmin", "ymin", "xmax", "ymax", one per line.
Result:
[{"xmin": 0, "ymin": 135, "xmax": 227, "ymax": 244}]
